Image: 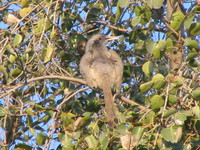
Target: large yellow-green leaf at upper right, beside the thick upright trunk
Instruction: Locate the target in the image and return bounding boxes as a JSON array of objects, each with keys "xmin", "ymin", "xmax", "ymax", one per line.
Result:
[{"xmin": 170, "ymin": 11, "xmax": 185, "ymax": 31}]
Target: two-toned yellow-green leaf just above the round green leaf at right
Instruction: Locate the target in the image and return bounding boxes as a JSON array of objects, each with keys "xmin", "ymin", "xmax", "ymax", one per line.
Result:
[{"xmin": 152, "ymin": 73, "xmax": 165, "ymax": 89}]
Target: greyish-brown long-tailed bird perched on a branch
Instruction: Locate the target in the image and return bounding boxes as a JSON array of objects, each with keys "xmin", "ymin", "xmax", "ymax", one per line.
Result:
[{"xmin": 79, "ymin": 34, "xmax": 124, "ymax": 127}]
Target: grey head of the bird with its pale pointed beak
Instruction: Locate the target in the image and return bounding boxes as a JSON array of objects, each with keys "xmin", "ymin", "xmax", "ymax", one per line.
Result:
[{"xmin": 86, "ymin": 34, "xmax": 118, "ymax": 52}]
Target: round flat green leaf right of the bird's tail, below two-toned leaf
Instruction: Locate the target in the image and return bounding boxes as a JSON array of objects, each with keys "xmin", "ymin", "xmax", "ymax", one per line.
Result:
[{"xmin": 151, "ymin": 95, "xmax": 164, "ymax": 110}]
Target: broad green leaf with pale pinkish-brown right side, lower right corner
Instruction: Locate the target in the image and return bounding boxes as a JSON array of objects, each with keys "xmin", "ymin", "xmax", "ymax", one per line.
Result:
[{"xmin": 161, "ymin": 126, "xmax": 182, "ymax": 143}]
